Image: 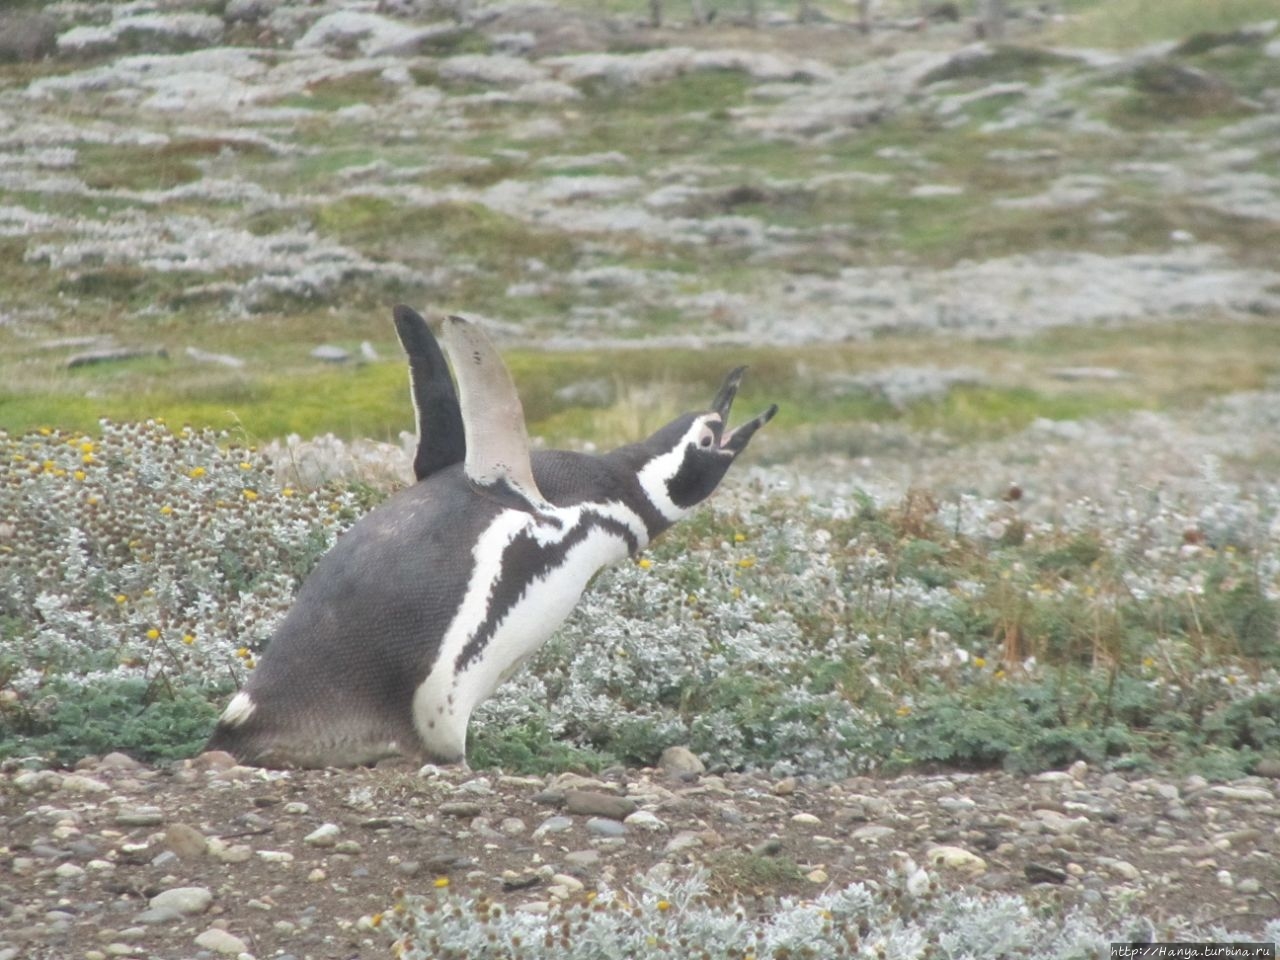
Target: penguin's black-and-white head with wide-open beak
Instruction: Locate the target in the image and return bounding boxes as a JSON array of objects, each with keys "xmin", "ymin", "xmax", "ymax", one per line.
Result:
[{"xmin": 637, "ymin": 367, "xmax": 778, "ymax": 524}]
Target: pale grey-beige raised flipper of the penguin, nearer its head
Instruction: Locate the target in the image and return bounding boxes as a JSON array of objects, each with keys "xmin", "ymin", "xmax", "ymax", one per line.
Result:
[{"xmin": 442, "ymin": 316, "xmax": 552, "ymax": 512}]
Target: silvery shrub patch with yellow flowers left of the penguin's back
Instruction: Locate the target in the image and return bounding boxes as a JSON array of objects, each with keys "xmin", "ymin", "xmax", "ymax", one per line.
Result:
[{"xmin": 0, "ymin": 421, "xmax": 356, "ymax": 757}]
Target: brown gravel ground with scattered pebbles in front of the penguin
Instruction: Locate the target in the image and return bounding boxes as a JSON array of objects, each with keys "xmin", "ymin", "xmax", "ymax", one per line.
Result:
[{"xmin": 0, "ymin": 749, "xmax": 1280, "ymax": 960}]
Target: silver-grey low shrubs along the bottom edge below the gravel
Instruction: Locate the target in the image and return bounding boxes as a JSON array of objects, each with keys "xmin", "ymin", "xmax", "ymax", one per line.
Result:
[{"xmin": 378, "ymin": 864, "xmax": 1280, "ymax": 960}]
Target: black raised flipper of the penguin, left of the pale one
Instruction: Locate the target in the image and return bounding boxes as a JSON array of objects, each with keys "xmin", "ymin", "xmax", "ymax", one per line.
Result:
[{"xmin": 392, "ymin": 305, "xmax": 467, "ymax": 480}]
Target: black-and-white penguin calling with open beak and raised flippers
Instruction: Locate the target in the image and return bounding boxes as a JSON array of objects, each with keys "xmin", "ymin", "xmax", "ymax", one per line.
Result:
[{"xmin": 206, "ymin": 307, "xmax": 777, "ymax": 767}]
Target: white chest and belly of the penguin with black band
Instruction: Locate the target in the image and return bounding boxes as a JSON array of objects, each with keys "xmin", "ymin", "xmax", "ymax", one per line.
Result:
[{"xmin": 413, "ymin": 502, "xmax": 648, "ymax": 760}]
